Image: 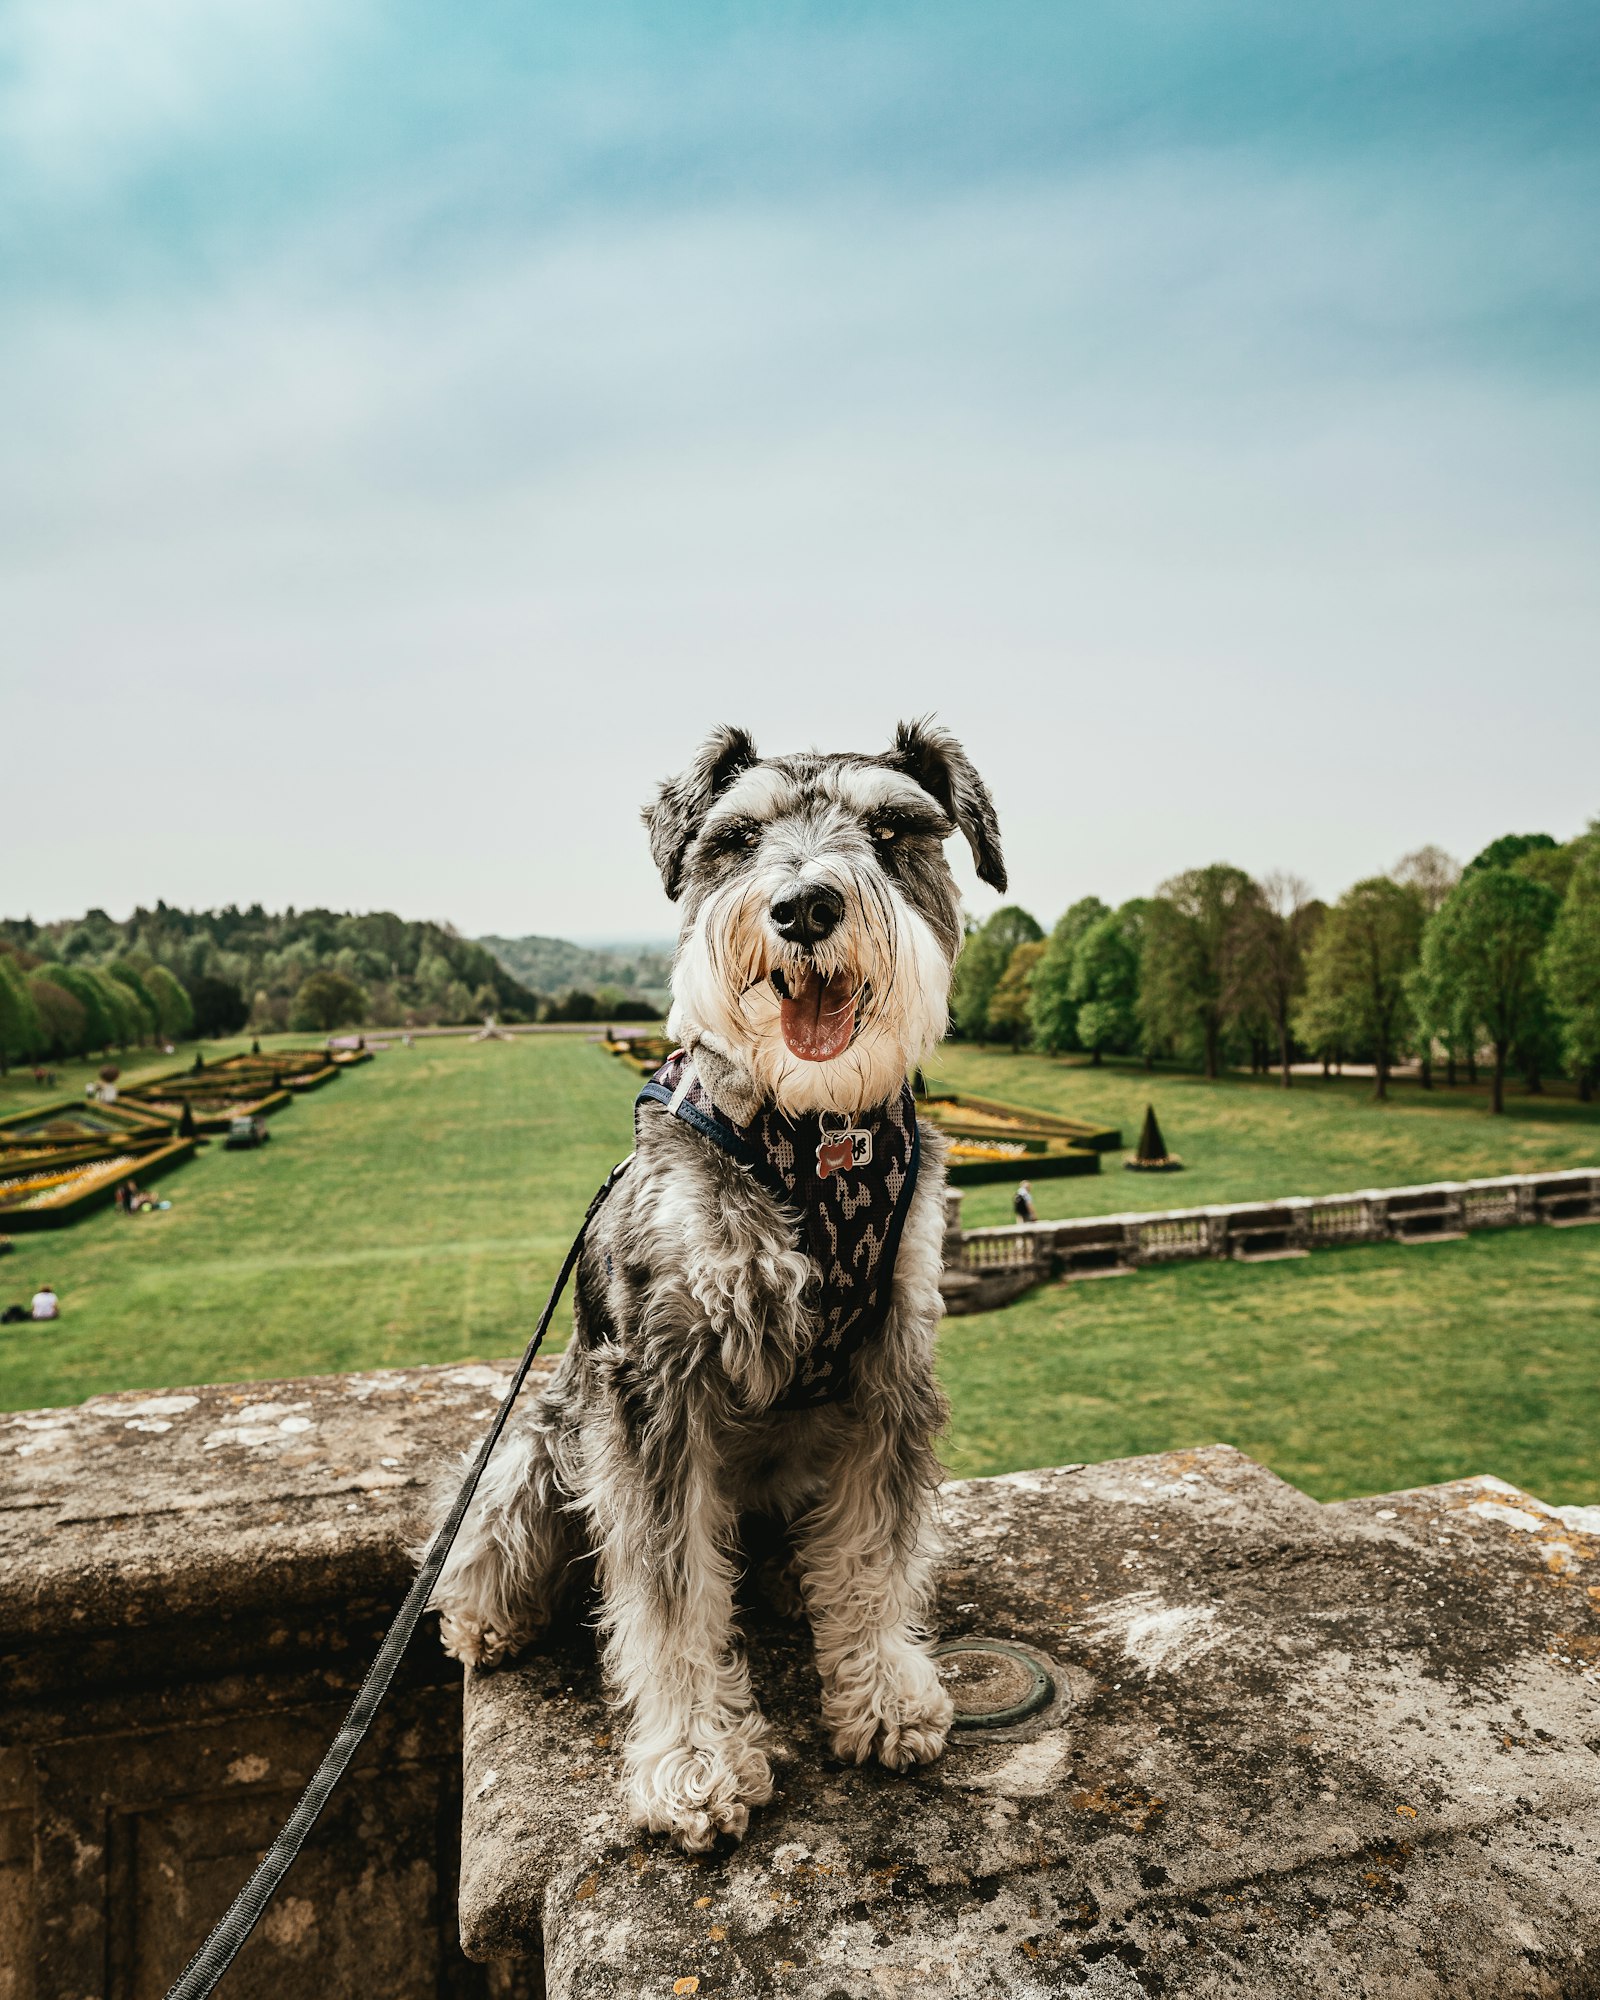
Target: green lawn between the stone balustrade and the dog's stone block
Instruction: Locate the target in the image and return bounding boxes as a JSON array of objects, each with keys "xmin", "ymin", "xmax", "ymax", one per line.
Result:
[{"xmin": 940, "ymin": 1226, "xmax": 1600, "ymax": 1504}]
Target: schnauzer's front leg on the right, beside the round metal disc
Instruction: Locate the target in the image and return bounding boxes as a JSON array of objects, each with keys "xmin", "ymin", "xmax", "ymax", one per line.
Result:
[{"xmin": 796, "ymin": 1432, "xmax": 952, "ymax": 1770}]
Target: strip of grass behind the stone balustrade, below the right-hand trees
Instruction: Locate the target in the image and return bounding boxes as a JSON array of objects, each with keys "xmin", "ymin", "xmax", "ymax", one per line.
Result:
[{"xmin": 930, "ymin": 1042, "xmax": 1600, "ymax": 1228}]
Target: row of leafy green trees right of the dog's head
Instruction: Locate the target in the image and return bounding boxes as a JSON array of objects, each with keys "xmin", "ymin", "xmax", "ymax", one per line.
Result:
[{"xmin": 950, "ymin": 820, "xmax": 1600, "ymax": 1112}]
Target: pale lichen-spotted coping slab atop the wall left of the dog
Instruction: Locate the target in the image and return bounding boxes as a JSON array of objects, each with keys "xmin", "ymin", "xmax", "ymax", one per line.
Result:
[{"xmin": 0, "ymin": 1362, "xmax": 554, "ymax": 1638}]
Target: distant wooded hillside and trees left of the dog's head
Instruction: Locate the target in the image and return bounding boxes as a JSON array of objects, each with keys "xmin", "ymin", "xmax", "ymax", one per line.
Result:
[{"xmin": 0, "ymin": 902, "xmax": 656, "ymax": 1074}]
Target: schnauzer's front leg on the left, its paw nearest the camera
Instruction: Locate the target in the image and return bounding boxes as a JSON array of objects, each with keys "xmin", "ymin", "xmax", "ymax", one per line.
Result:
[{"xmin": 584, "ymin": 1454, "xmax": 772, "ymax": 1854}]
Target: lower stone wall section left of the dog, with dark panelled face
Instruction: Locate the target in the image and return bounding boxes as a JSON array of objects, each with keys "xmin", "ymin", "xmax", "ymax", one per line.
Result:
[{"xmin": 0, "ymin": 1336, "xmax": 552, "ymax": 2000}]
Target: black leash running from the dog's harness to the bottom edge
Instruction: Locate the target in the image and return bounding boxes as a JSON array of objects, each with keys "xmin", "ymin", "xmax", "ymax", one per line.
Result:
[{"xmin": 166, "ymin": 1160, "xmax": 628, "ymax": 2000}]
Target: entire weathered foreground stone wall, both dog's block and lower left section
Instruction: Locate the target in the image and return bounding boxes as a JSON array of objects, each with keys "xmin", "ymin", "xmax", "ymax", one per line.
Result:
[{"xmin": 0, "ymin": 1336, "xmax": 1600, "ymax": 2000}]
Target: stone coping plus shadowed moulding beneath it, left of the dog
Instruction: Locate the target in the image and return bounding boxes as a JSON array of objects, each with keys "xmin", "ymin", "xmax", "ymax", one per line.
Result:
[{"xmin": 0, "ymin": 1364, "xmax": 554, "ymax": 1742}]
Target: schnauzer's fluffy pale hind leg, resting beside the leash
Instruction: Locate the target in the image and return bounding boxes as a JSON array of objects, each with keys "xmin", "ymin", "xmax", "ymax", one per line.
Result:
[{"xmin": 430, "ymin": 1420, "xmax": 580, "ymax": 1668}]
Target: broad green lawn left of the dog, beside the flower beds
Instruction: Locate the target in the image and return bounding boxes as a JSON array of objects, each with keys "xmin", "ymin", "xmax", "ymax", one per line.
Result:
[{"xmin": 0, "ymin": 1036, "xmax": 636, "ymax": 1410}]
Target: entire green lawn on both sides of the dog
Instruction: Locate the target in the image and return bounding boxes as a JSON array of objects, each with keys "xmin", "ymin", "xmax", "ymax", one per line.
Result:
[{"xmin": 0, "ymin": 1036, "xmax": 1600, "ymax": 1502}]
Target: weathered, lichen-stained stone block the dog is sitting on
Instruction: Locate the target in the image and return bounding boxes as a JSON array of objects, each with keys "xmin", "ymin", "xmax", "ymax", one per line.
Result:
[{"xmin": 460, "ymin": 1446, "xmax": 1600, "ymax": 2000}]
